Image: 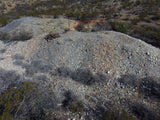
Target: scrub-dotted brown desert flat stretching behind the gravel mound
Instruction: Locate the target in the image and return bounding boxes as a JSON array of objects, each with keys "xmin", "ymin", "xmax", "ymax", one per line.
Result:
[{"xmin": 0, "ymin": 0, "xmax": 160, "ymax": 47}]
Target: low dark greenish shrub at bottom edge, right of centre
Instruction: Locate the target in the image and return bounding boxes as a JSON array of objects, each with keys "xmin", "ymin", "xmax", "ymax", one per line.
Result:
[{"xmin": 102, "ymin": 109, "xmax": 136, "ymax": 120}]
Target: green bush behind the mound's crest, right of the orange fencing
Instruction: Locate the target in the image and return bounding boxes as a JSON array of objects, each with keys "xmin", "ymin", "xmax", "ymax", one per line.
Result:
[{"xmin": 111, "ymin": 21, "xmax": 130, "ymax": 33}]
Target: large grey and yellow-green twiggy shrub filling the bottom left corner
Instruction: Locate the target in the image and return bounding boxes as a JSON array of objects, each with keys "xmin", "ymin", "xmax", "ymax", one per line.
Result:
[{"xmin": 0, "ymin": 81, "xmax": 52, "ymax": 120}]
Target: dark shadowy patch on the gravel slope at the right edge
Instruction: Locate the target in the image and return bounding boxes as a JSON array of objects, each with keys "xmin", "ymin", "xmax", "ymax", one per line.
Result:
[{"xmin": 118, "ymin": 75, "xmax": 160, "ymax": 99}]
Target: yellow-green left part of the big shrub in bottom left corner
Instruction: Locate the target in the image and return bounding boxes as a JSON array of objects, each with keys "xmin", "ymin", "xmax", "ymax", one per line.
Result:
[{"xmin": 0, "ymin": 82, "xmax": 36, "ymax": 120}]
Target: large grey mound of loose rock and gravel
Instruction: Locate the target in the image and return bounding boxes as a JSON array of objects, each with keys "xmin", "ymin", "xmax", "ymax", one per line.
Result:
[{"xmin": 0, "ymin": 17, "xmax": 160, "ymax": 120}]
